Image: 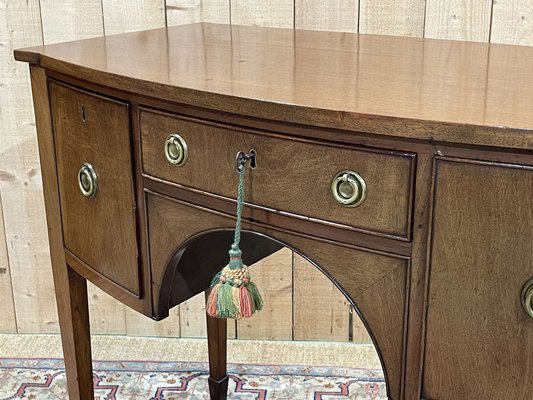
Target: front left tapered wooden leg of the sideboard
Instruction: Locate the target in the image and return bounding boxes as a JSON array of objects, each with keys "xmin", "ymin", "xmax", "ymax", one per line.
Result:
[{"xmin": 54, "ymin": 266, "xmax": 94, "ymax": 400}]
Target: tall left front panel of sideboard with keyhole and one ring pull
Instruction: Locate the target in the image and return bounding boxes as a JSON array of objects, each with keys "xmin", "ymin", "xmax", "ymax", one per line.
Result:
[{"xmin": 50, "ymin": 82, "xmax": 139, "ymax": 295}]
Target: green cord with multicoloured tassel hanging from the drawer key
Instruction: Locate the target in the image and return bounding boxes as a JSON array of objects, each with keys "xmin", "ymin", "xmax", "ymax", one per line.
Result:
[{"xmin": 206, "ymin": 160, "xmax": 263, "ymax": 319}]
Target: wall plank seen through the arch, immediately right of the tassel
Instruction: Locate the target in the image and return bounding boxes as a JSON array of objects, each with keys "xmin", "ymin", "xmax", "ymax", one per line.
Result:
[{"xmin": 237, "ymin": 248, "xmax": 293, "ymax": 340}]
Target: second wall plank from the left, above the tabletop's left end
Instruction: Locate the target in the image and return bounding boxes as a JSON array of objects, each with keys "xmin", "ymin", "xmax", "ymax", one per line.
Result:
[{"xmin": 41, "ymin": 0, "xmax": 104, "ymax": 44}]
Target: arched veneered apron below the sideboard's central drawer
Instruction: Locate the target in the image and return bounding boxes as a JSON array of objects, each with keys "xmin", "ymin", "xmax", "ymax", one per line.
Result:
[{"xmin": 147, "ymin": 194, "xmax": 407, "ymax": 399}]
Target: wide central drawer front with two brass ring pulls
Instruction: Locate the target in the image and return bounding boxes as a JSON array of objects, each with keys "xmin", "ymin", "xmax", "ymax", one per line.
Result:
[{"xmin": 139, "ymin": 110, "xmax": 414, "ymax": 239}]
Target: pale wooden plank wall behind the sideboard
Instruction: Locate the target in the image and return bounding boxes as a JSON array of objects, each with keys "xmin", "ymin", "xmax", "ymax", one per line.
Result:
[{"xmin": 0, "ymin": 0, "xmax": 533, "ymax": 342}]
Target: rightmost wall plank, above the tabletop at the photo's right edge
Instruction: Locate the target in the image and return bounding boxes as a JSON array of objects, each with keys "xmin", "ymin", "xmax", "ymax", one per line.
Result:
[{"xmin": 490, "ymin": 0, "xmax": 533, "ymax": 46}]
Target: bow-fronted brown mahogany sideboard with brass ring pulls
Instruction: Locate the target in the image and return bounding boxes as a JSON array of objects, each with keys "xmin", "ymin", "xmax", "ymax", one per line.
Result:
[{"xmin": 15, "ymin": 24, "xmax": 533, "ymax": 400}]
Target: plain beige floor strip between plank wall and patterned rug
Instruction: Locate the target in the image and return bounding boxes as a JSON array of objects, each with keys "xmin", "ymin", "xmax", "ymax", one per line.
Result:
[{"xmin": 0, "ymin": 335, "xmax": 381, "ymax": 369}]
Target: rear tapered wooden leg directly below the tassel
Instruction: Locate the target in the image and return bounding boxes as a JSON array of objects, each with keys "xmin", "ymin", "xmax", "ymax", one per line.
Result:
[{"xmin": 205, "ymin": 291, "xmax": 228, "ymax": 400}]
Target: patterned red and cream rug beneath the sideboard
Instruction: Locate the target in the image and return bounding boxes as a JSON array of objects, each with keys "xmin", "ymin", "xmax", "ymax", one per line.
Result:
[{"xmin": 0, "ymin": 358, "xmax": 386, "ymax": 400}]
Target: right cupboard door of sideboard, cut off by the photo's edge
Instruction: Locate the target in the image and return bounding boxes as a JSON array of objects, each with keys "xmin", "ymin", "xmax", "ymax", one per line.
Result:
[{"xmin": 423, "ymin": 160, "xmax": 533, "ymax": 400}]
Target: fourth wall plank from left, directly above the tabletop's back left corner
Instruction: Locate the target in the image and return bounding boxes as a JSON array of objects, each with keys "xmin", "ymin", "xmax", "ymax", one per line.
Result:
[{"xmin": 166, "ymin": 0, "xmax": 230, "ymax": 26}]
